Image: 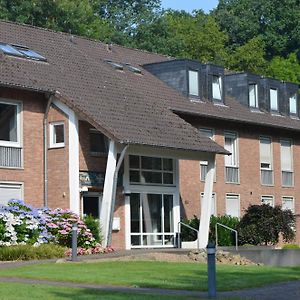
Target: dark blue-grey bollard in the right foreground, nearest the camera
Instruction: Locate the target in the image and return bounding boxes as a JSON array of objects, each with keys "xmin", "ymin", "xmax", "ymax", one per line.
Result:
[{"xmin": 207, "ymin": 242, "xmax": 217, "ymax": 298}]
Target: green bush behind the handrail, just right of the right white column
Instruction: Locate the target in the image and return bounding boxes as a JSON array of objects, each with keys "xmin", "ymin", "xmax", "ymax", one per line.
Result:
[{"xmin": 209, "ymin": 215, "xmax": 239, "ymax": 246}]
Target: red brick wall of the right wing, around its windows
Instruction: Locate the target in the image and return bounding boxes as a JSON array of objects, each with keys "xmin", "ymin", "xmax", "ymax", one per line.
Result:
[{"xmin": 180, "ymin": 119, "xmax": 300, "ymax": 242}]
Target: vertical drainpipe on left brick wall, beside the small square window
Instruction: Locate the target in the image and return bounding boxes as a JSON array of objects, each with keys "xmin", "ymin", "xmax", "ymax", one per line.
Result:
[{"xmin": 43, "ymin": 95, "xmax": 53, "ymax": 208}]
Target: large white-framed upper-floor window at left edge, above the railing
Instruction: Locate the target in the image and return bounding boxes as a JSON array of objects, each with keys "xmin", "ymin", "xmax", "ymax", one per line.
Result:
[{"xmin": 0, "ymin": 99, "xmax": 21, "ymax": 147}]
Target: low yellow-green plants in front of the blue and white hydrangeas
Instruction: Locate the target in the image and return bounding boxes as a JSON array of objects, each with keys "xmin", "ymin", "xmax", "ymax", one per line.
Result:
[{"xmin": 0, "ymin": 244, "xmax": 65, "ymax": 261}]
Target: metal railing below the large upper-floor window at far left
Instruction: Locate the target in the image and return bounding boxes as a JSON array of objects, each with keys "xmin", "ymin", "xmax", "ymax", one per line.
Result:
[{"xmin": 0, "ymin": 146, "xmax": 22, "ymax": 168}]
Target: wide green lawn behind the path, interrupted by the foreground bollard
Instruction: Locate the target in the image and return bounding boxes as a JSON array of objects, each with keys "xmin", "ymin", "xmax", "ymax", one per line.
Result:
[{"xmin": 1, "ymin": 261, "xmax": 300, "ymax": 291}]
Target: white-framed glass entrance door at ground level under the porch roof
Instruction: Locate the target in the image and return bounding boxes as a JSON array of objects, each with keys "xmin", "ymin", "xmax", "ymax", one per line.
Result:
[{"xmin": 130, "ymin": 193, "xmax": 175, "ymax": 248}]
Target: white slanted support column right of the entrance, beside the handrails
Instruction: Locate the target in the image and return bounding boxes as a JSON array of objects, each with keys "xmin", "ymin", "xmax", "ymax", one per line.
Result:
[{"xmin": 198, "ymin": 155, "xmax": 215, "ymax": 248}]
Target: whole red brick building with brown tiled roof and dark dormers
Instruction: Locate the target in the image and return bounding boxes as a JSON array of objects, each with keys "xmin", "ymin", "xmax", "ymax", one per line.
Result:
[{"xmin": 0, "ymin": 22, "xmax": 300, "ymax": 249}]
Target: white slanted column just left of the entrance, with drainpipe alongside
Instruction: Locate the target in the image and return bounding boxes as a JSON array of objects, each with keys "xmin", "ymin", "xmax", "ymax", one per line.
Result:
[{"xmin": 100, "ymin": 140, "xmax": 117, "ymax": 246}]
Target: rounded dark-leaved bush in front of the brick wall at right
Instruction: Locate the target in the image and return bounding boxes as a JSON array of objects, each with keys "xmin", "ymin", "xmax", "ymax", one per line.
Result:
[{"xmin": 238, "ymin": 204, "xmax": 295, "ymax": 245}]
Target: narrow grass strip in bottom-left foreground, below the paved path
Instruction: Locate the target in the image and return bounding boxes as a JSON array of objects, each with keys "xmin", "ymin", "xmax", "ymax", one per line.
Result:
[{"xmin": 0, "ymin": 282, "xmax": 195, "ymax": 300}]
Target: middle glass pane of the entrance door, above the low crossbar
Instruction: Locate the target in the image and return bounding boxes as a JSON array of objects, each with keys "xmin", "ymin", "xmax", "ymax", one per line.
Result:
[{"xmin": 141, "ymin": 194, "xmax": 162, "ymax": 233}]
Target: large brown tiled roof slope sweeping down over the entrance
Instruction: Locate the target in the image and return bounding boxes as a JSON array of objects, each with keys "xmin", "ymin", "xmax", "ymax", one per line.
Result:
[{"xmin": 0, "ymin": 21, "xmax": 227, "ymax": 153}]
